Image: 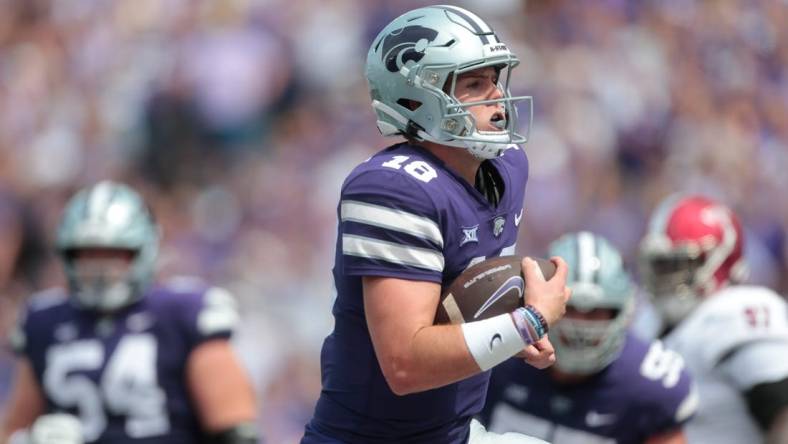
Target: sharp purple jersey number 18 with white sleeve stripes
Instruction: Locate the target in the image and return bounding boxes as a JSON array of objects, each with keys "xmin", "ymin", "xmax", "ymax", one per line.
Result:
[{"xmin": 302, "ymin": 144, "xmax": 528, "ymax": 444}]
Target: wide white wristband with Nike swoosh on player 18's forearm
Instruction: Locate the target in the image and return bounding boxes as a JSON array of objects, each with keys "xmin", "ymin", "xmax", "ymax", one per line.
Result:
[{"xmin": 460, "ymin": 313, "xmax": 526, "ymax": 371}]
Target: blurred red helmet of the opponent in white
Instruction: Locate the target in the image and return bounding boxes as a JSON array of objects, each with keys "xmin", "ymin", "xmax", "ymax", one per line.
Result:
[{"xmin": 640, "ymin": 196, "xmax": 747, "ymax": 325}]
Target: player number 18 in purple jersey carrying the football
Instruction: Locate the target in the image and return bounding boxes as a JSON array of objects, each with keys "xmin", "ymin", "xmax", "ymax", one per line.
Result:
[{"xmin": 302, "ymin": 6, "xmax": 569, "ymax": 444}]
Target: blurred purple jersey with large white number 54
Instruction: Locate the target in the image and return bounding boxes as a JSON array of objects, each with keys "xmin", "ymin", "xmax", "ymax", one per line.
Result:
[{"xmin": 16, "ymin": 281, "xmax": 232, "ymax": 444}]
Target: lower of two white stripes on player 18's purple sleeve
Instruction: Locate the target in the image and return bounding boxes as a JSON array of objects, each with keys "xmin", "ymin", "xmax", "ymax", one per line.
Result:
[{"xmin": 342, "ymin": 234, "xmax": 444, "ymax": 271}]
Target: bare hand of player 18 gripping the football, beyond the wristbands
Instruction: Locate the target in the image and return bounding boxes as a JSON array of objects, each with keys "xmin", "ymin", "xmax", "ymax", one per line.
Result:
[{"xmin": 517, "ymin": 257, "xmax": 571, "ymax": 369}]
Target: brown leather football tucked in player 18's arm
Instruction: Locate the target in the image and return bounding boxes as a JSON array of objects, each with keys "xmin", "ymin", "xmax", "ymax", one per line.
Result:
[{"xmin": 435, "ymin": 256, "xmax": 555, "ymax": 324}]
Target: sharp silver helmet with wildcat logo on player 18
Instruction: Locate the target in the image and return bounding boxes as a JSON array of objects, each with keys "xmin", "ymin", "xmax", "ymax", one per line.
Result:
[{"xmin": 366, "ymin": 5, "xmax": 533, "ymax": 159}]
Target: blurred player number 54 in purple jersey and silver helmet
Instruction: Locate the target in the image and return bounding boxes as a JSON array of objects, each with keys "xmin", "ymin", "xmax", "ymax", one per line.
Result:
[{"xmin": 0, "ymin": 181, "xmax": 257, "ymax": 444}]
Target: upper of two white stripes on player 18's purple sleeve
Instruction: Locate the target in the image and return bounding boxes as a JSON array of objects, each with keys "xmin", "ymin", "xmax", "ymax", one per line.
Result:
[{"xmin": 340, "ymin": 200, "xmax": 443, "ymax": 247}]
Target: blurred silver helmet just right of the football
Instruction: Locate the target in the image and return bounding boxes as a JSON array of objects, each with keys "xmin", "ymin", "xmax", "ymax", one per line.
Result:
[{"xmin": 549, "ymin": 231, "xmax": 635, "ymax": 375}]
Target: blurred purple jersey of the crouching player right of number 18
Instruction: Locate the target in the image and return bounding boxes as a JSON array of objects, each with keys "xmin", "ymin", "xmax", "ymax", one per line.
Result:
[{"xmin": 481, "ymin": 334, "xmax": 696, "ymax": 444}]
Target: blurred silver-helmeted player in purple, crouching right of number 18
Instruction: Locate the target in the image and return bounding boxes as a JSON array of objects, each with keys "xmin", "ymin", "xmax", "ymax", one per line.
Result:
[{"xmin": 482, "ymin": 231, "xmax": 697, "ymax": 444}]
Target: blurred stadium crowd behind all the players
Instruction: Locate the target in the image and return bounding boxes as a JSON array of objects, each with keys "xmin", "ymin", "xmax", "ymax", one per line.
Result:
[{"xmin": 0, "ymin": 0, "xmax": 788, "ymax": 443}]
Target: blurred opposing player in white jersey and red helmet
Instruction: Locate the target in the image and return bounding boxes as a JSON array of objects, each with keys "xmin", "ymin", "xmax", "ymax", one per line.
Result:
[{"xmin": 641, "ymin": 195, "xmax": 788, "ymax": 444}]
